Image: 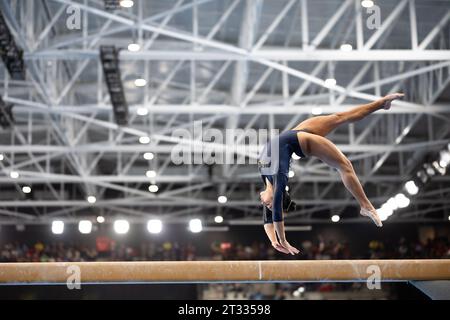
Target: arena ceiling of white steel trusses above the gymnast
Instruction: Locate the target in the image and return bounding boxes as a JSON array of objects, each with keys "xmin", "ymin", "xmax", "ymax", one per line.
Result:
[{"xmin": 0, "ymin": 0, "xmax": 450, "ymax": 224}]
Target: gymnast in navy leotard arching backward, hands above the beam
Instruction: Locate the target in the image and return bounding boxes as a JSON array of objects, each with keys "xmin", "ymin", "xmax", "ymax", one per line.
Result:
[{"xmin": 258, "ymin": 93, "xmax": 404, "ymax": 255}]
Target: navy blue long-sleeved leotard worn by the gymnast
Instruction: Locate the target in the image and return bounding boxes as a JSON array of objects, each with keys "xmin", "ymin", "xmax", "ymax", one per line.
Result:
[{"xmin": 258, "ymin": 130, "xmax": 306, "ymax": 224}]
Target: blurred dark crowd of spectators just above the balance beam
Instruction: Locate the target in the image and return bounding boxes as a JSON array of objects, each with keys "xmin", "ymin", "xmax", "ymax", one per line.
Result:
[{"xmin": 0, "ymin": 238, "xmax": 450, "ymax": 262}]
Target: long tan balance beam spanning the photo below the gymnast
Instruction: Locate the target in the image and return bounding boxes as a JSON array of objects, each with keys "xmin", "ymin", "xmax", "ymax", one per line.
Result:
[{"xmin": 0, "ymin": 259, "xmax": 450, "ymax": 284}]
